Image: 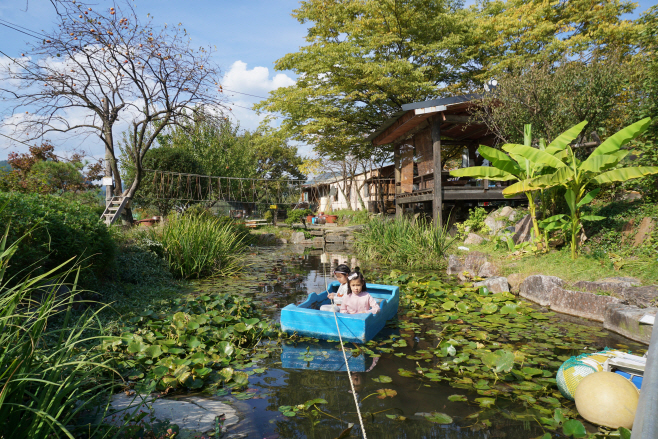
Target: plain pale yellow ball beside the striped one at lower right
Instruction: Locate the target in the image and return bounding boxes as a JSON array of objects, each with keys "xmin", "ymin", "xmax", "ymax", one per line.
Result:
[{"xmin": 575, "ymin": 372, "xmax": 639, "ymax": 429}]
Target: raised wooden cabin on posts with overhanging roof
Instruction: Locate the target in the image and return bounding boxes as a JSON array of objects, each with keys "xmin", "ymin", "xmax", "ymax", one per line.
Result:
[{"xmin": 368, "ymin": 95, "xmax": 521, "ymax": 225}]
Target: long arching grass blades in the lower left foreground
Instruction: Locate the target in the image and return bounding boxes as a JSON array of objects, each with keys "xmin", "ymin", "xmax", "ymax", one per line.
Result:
[{"xmin": 0, "ymin": 220, "xmax": 119, "ymax": 439}]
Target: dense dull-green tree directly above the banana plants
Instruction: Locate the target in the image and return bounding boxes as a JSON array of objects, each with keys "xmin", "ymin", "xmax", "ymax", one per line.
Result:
[{"xmin": 475, "ymin": 56, "xmax": 629, "ymax": 143}]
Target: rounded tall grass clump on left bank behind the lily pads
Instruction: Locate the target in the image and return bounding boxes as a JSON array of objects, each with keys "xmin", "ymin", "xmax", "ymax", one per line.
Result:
[{"xmin": 146, "ymin": 216, "xmax": 246, "ymax": 279}]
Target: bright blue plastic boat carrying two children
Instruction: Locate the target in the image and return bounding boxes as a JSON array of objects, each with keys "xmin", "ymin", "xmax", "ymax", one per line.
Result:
[{"xmin": 281, "ymin": 282, "xmax": 400, "ymax": 343}]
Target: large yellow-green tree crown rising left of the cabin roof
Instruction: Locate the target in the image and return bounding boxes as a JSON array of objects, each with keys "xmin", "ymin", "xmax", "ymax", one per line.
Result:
[{"xmin": 256, "ymin": 0, "xmax": 474, "ymax": 160}]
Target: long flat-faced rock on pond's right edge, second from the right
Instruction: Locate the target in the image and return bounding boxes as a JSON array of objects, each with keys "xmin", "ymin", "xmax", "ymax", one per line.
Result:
[{"xmin": 550, "ymin": 287, "xmax": 621, "ymax": 322}]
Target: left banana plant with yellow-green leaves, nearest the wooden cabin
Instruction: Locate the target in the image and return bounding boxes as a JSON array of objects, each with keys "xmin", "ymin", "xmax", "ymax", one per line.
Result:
[{"xmin": 450, "ymin": 124, "xmax": 573, "ymax": 244}]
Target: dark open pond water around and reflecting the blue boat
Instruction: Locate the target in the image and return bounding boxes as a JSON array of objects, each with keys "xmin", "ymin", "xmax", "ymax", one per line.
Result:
[{"xmin": 188, "ymin": 246, "xmax": 643, "ymax": 439}]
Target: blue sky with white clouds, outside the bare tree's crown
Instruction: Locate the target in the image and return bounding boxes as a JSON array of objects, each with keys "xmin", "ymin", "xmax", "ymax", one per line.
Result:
[{"xmin": 0, "ymin": 0, "xmax": 655, "ymax": 160}]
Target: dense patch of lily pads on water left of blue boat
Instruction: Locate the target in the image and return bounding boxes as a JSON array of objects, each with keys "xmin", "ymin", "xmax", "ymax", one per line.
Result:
[{"xmin": 103, "ymin": 294, "xmax": 270, "ymax": 392}]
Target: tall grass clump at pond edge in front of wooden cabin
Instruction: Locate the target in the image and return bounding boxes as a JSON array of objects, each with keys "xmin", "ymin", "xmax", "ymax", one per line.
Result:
[{"xmin": 355, "ymin": 217, "xmax": 455, "ymax": 269}]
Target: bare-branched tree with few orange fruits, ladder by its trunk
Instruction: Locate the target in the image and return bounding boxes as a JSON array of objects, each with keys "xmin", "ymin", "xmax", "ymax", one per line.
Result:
[{"xmin": 0, "ymin": 0, "xmax": 225, "ymax": 212}]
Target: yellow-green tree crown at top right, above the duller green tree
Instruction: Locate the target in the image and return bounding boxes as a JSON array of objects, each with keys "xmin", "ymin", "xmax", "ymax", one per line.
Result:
[{"xmin": 464, "ymin": 0, "xmax": 640, "ymax": 77}]
